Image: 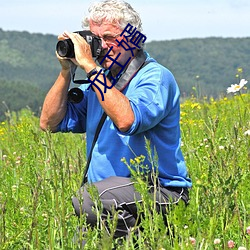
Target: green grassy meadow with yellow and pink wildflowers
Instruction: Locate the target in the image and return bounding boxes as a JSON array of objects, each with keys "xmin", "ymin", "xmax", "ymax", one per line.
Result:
[{"xmin": 0, "ymin": 89, "xmax": 250, "ymax": 250}]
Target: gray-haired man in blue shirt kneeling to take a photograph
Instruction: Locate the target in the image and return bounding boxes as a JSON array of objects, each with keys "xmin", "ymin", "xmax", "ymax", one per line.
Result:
[{"xmin": 40, "ymin": 0, "xmax": 191, "ymax": 242}]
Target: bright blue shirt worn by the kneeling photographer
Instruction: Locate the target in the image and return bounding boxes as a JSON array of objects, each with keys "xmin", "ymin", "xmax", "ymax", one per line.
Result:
[{"xmin": 58, "ymin": 53, "xmax": 192, "ymax": 187}]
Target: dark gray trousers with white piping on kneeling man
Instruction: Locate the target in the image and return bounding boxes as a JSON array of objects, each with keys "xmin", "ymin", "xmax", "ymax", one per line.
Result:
[{"xmin": 72, "ymin": 176, "xmax": 189, "ymax": 238}]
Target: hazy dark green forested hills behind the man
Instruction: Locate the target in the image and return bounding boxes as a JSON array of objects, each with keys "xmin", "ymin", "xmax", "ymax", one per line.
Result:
[{"xmin": 0, "ymin": 29, "xmax": 250, "ymax": 120}]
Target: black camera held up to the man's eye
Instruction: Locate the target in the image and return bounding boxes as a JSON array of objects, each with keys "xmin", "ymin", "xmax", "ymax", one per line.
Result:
[{"xmin": 56, "ymin": 30, "xmax": 102, "ymax": 58}]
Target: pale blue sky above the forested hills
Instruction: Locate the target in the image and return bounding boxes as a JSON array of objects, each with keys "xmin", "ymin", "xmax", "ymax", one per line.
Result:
[{"xmin": 0, "ymin": 0, "xmax": 250, "ymax": 41}]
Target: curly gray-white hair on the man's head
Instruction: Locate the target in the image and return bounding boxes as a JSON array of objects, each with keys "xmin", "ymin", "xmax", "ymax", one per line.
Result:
[{"xmin": 82, "ymin": 0, "xmax": 142, "ymax": 32}]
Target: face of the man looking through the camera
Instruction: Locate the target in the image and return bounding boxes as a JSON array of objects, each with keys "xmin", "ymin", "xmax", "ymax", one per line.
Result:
[{"xmin": 90, "ymin": 20, "xmax": 131, "ymax": 72}]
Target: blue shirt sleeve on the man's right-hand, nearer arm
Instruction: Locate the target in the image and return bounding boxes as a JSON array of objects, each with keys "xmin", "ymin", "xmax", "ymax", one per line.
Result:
[{"xmin": 121, "ymin": 63, "xmax": 180, "ymax": 135}]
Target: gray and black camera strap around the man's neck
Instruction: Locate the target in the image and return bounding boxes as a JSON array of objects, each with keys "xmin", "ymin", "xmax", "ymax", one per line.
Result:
[{"xmin": 81, "ymin": 50, "xmax": 150, "ymax": 187}]
